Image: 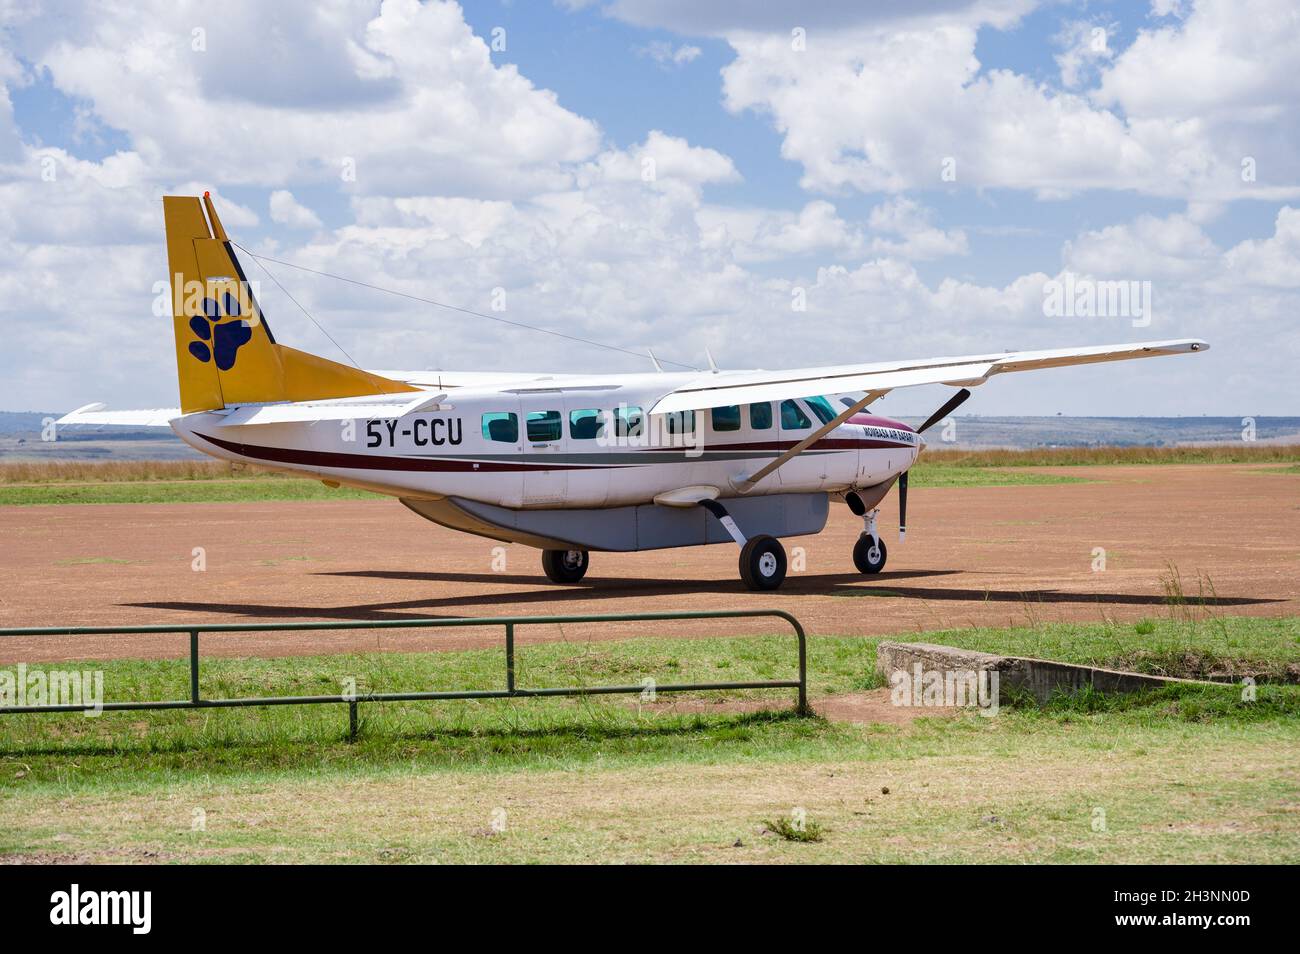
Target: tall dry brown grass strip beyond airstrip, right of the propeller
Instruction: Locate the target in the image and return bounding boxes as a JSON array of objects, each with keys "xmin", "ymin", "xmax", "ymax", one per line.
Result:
[{"xmin": 919, "ymin": 442, "xmax": 1300, "ymax": 467}]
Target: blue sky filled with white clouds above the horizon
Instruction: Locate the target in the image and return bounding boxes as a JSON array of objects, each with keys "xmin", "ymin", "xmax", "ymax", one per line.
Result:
[{"xmin": 0, "ymin": 0, "xmax": 1300, "ymax": 416}]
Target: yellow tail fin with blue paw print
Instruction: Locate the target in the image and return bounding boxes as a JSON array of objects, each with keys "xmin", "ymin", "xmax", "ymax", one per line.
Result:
[{"xmin": 163, "ymin": 192, "xmax": 420, "ymax": 413}]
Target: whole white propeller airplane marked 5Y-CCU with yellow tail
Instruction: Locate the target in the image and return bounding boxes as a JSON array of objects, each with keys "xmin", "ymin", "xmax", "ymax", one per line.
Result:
[{"xmin": 57, "ymin": 192, "xmax": 1209, "ymax": 590}]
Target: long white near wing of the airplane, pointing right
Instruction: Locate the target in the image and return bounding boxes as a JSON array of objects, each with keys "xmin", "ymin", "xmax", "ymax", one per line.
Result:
[{"xmin": 650, "ymin": 338, "xmax": 1210, "ymax": 415}]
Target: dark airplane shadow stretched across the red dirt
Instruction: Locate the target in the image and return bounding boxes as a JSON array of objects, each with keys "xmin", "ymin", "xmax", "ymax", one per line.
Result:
[{"xmin": 122, "ymin": 569, "xmax": 1284, "ymax": 620}]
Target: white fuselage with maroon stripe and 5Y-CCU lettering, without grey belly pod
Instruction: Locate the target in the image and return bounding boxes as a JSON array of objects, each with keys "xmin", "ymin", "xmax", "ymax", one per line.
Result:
[{"xmin": 173, "ymin": 374, "xmax": 924, "ymax": 509}]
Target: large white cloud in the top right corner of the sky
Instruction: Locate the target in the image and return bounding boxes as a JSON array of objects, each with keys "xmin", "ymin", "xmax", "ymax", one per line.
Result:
[{"xmin": 702, "ymin": 0, "xmax": 1300, "ymax": 200}]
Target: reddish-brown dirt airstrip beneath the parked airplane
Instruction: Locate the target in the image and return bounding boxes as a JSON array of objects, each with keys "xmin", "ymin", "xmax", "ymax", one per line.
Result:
[{"xmin": 0, "ymin": 465, "xmax": 1300, "ymax": 663}]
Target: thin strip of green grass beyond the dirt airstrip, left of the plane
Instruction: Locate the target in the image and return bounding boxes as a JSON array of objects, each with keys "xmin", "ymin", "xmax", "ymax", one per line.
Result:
[{"xmin": 0, "ymin": 477, "xmax": 374, "ymax": 507}]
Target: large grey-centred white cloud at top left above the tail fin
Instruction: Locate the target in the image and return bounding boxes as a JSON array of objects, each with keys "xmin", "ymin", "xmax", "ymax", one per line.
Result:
[{"xmin": 20, "ymin": 0, "xmax": 599, "ymax": 195}]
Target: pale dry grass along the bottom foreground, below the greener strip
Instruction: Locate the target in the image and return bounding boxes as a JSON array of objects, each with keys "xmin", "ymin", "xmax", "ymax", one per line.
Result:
[{"xmin": 0, "ymin": 725, "xmax": 1297, "ymax": 863}]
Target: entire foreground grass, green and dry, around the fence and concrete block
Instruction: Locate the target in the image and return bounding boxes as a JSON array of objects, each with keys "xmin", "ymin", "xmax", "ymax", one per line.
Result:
[{"xmin": 0, "ymin": 617, "xmax": 1300, "ymax": 863}]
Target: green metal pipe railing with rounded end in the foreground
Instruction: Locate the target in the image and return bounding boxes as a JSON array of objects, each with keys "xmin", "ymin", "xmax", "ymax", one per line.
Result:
[{"xmin": 0, "ymin": 610, "xmax": 810, "ymax": 738}]
